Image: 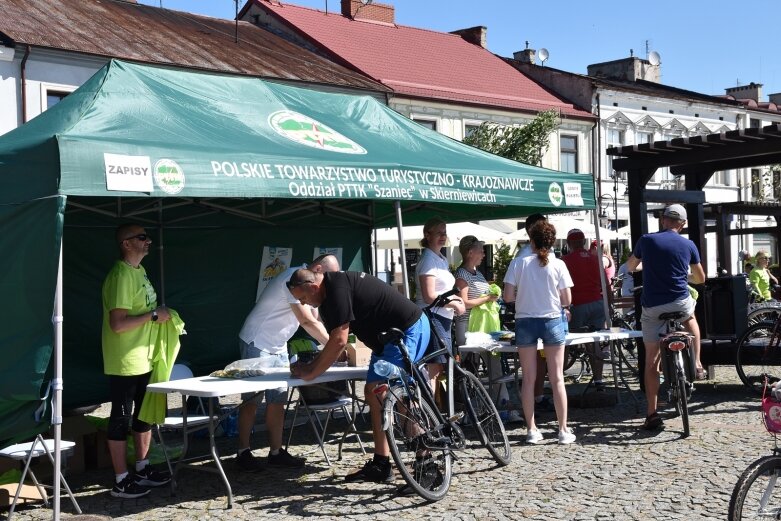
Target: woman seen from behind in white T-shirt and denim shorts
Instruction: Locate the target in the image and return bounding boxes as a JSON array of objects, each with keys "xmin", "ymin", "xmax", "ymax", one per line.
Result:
[{"xmin": 504, "ymin": 221, "xmax": 575, "ymax": 444}]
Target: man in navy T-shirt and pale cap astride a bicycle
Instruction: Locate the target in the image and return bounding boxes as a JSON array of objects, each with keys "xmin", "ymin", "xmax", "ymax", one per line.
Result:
[{"xmin": 627, "ymin": 204, "xmax": 705, "ymax": 430}]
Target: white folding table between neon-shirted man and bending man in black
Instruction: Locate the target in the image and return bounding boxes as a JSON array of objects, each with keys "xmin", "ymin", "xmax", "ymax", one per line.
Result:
[{"xmin": 147, "ymin": 367, "xmax": 368, "ymax": 507}]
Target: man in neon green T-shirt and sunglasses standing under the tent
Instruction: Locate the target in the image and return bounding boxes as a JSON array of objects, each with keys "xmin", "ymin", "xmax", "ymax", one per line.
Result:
[{"xmin": 102, "ymin": 224, "xmax": 171, "ymax": 499}]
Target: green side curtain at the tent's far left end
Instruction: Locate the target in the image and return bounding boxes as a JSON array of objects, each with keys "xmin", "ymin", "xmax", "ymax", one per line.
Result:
[{"xmin": 0, "ymin": 197, "xmax": 65, "ymax": 446}]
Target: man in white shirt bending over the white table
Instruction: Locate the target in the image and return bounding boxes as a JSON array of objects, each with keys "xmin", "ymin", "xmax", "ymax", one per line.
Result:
[{"xmin": 236, "ymin": 255, "xmax": 339, "ymax": 472}]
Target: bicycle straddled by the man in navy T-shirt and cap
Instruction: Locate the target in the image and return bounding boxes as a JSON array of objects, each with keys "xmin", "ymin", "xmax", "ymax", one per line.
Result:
[{"xmin": 659, "ymin": 311, "xmax": 696, "ymax": 438}]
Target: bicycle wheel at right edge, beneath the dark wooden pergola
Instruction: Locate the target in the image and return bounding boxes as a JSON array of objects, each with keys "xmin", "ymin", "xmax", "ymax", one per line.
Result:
[{"xmin": 735, "ymin": 322, "xmax": 781, "ymax": 394}]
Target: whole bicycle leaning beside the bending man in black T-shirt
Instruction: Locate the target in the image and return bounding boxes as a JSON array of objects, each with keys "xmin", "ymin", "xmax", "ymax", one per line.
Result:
[{"xmin": 375, "ymin": 290, "xmax": 512, "ymax": 501}]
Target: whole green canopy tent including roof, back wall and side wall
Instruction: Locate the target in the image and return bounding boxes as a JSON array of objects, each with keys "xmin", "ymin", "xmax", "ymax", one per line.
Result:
[{"xmin": 0, "ymin": 61, "xmax": 596, "ymax": 443}]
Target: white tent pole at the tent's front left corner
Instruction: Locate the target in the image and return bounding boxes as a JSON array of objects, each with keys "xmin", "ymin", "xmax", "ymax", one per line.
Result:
[{"xmin": 52, "ymin": 239, "xmax": 62, "ymax": 521}]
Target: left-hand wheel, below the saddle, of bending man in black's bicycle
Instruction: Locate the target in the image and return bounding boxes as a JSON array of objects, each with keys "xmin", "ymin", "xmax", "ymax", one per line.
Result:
[{"xmin": 385, "ymin": 387, "xmax": 453, "ymax": 501}]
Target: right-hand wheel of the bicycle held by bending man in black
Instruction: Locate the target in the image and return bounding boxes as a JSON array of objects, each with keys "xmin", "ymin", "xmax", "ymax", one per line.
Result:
[{"xmin": 457, "ymin": 369, "xmax": 512, "ymax": 466}]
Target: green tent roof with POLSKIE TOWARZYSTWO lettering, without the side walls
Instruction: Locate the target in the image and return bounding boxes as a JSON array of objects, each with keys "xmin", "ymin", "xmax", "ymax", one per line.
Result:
[{"xmin": 0, "ymin": 60, "xmax": 595, "ymax": 226}]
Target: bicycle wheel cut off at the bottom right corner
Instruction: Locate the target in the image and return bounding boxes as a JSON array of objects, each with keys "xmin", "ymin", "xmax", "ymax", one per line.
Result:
[{"xmin": 728, "ymin": 456, "xmax": 781, "ymax": 521}]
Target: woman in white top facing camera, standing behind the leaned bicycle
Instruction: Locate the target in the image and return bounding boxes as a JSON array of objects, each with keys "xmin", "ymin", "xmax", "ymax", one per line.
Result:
[{"xmin": 415, "ymin": 218, "xmax": 464, "ymax": 381}]
